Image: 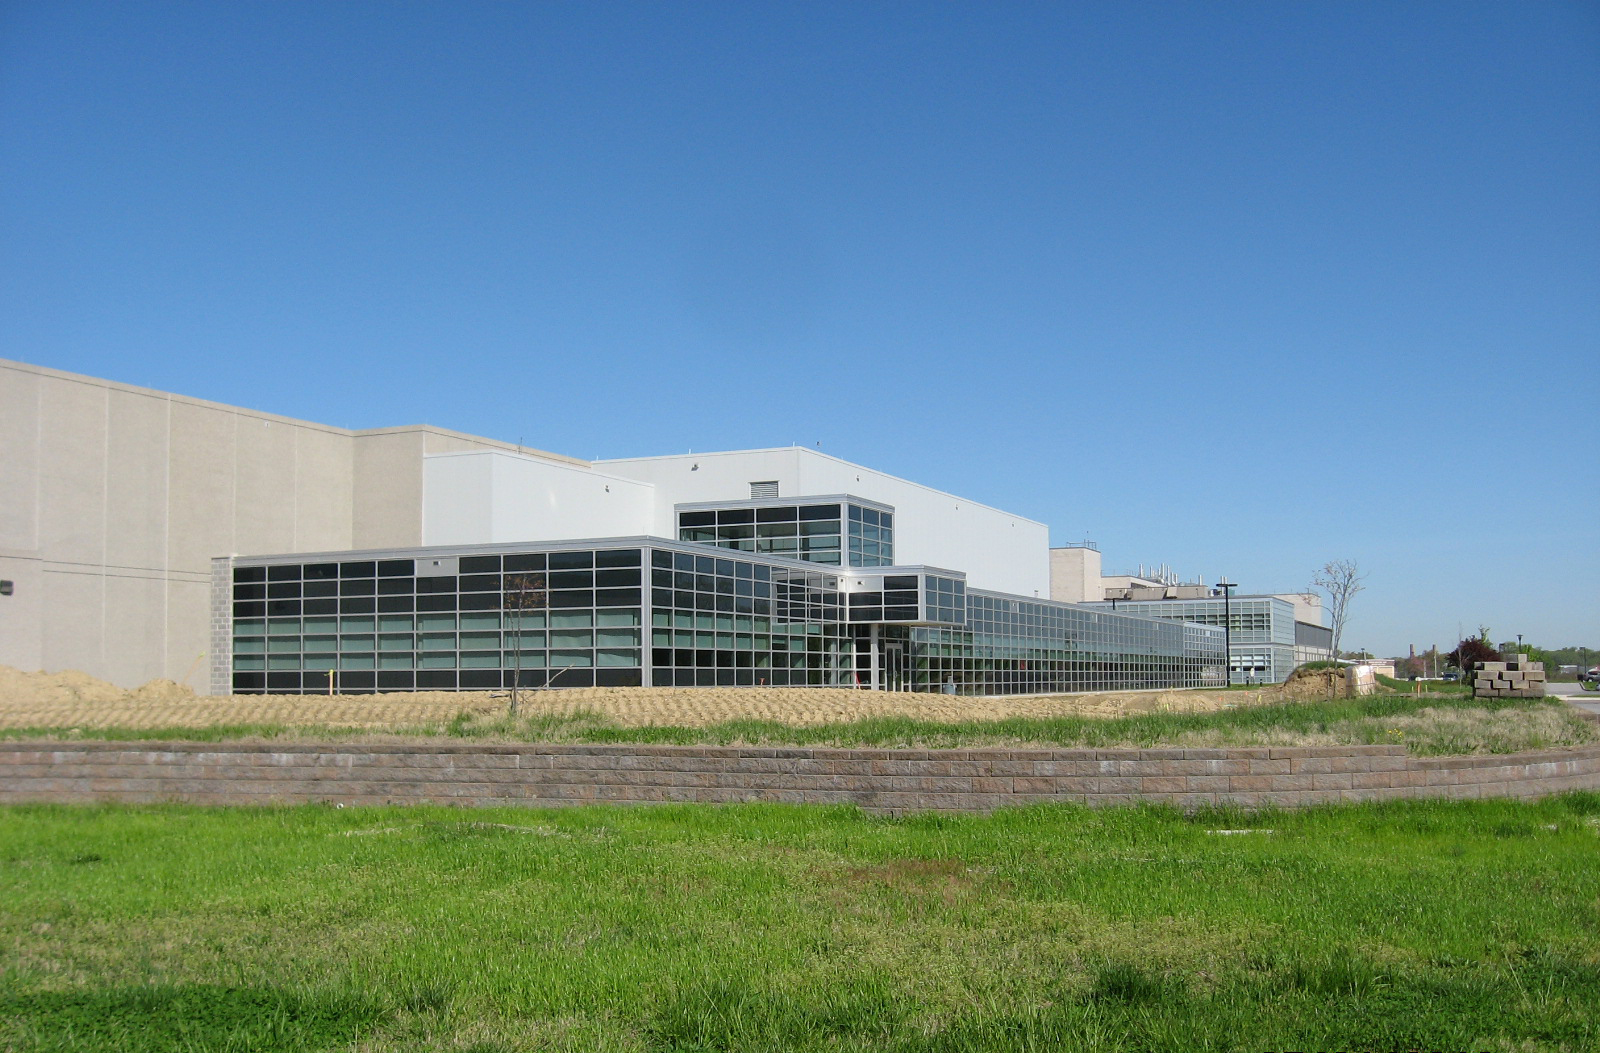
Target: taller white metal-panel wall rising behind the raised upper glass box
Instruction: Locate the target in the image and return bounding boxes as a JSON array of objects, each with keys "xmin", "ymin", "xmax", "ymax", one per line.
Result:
[{"xmin": 595, "ymin": 446, "xmax": 1050, "ymax": 597}]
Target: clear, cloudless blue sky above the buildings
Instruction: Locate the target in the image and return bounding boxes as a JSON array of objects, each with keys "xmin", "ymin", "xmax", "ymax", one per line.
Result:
[{"xmin": 0, "ymin": 0, "xmax": 1600, "ymax": 653}]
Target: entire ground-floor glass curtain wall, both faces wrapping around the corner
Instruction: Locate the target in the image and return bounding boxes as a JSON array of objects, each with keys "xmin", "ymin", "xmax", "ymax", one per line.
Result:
[{"xmin": 232, "ymin": 544, "xmax": 1222, "ymax": 695}]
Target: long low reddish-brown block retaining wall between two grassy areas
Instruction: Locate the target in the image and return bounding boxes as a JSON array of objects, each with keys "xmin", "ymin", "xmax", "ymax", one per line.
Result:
[{"xmin": 0, "ymin": 743, "xmax": 1600, "ymax": 811}]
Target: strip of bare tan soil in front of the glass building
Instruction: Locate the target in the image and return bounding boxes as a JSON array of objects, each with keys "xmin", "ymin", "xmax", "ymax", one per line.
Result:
[{"xmin": 0, "ymin": 666, "xmax": 1286, "ymax": 730}]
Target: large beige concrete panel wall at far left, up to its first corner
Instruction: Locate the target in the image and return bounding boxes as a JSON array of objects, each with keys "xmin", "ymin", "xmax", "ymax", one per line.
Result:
[{"xmin": 0, "ymin": 360, "xmax": 368, "ymax": 687}]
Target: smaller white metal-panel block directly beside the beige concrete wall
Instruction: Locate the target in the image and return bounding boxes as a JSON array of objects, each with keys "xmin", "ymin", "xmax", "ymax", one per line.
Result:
[{"xmin": 422, "ymin": 451, "xmax": 656, "ymax": 544}]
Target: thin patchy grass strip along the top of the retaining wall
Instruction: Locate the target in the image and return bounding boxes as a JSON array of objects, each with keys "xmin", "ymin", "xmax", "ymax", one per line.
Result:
[{"xmin": 9, "ymin": 695, "xmax": 1600, "ymax": 755}]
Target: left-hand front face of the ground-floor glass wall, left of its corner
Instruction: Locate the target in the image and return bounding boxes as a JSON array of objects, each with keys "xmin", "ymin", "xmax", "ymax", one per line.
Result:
[{"xmin": 234, "ymin": 549, "xmax": 643, "ymax": 695}]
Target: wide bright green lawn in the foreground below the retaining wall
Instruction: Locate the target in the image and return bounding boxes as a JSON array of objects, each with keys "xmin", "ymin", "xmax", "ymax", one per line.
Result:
[{"xmin": 0, "ymin": 794, "xmax": 1600, "ymax": 1053}]
